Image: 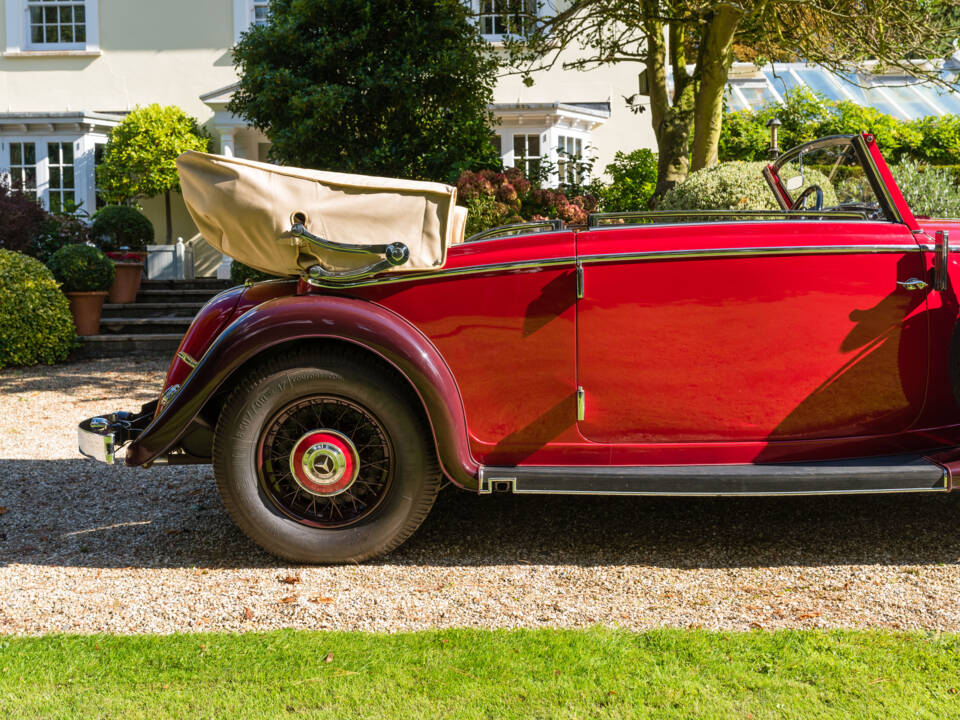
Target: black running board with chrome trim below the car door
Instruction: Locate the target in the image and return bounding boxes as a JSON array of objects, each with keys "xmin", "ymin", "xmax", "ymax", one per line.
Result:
[{"xmin": 480, "ymin": 455, "xmax": 949, "ymax": 495}]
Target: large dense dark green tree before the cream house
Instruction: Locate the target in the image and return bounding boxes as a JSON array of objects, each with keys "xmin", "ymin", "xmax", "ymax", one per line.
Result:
[{"xmin": 229, "ymin": 0, "xmax": 499, "ymax": 181}]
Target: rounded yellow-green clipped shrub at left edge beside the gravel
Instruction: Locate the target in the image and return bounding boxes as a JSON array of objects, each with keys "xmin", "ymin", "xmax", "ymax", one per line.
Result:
[{"xmin": 0, "ymin": 249, "xmax": 76, "ymax": 368}]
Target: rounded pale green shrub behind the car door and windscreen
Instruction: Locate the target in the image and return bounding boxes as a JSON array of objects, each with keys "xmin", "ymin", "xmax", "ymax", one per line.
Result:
[{"xmin": 659, "ymin": 162, "xmax": 837, "ymax": 210}]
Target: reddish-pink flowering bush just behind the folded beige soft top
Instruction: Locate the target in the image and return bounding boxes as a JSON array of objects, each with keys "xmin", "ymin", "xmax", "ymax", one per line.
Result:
[{"xmin": 457, "ymin": 168, "xmax": 597, "ymax": 235}]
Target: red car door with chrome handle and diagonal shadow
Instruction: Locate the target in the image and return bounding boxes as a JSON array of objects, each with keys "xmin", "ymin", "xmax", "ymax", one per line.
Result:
[{"xmin": 577, "ymin": 220, "xmax": 928, "ymax": 443}]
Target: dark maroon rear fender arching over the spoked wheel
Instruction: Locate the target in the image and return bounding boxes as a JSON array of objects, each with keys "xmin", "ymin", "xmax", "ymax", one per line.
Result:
[{"xmin": 126, "ymin": 295, "xmax": 479, "ymax": 489}]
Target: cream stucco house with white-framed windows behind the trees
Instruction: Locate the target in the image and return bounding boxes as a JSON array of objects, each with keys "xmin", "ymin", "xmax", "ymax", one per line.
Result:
[{"xmin": 0, "ymin": 0, "xmax": 653, "ymax": 272}]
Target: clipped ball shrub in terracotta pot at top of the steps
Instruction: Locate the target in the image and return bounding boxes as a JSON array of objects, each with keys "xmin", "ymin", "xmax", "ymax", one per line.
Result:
[{"xmin": 90, "ymin": 205, "xmax": 153, "ymax": 303}]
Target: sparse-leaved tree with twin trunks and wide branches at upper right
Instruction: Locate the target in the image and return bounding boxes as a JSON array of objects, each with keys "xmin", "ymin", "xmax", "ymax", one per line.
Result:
[{"xmin": 507, "ymin": 0, "xmax": 960, "ymax": 196}]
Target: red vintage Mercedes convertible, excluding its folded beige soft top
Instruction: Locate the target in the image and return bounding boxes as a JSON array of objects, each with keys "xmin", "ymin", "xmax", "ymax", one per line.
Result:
[{"xmin": 79, "ymin": 134, "xmax": 960, "ymax": 562}]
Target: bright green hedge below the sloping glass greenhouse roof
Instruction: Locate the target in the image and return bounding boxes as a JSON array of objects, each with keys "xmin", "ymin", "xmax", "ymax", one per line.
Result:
[{"xmin": 719, "ymin": 88, "xmax": 960, "ymax": 164}]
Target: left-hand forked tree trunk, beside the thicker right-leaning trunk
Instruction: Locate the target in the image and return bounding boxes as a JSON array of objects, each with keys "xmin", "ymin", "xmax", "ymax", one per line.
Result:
[{"xmin": 644, "ymin": 9, "xmax": 694, "ymax": 204}]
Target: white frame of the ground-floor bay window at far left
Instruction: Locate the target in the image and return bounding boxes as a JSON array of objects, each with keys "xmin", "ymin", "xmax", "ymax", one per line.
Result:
[{"xmin": 0, "ymin": 132, "xmax": 107, "ymax": 215}]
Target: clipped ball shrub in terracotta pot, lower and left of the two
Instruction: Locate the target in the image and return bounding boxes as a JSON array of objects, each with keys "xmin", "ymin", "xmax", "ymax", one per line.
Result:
[{"xmin": 47, "ymin": 245, "xmax": 116, "ymax": 335}]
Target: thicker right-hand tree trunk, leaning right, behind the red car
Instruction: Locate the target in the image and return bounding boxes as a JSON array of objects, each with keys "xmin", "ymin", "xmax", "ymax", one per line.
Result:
[{"xmin": 693, "ymin": 4, "xmax": 743, "ymax": 171}]
